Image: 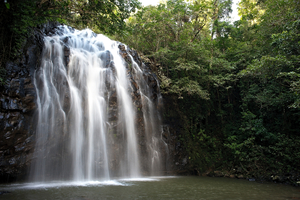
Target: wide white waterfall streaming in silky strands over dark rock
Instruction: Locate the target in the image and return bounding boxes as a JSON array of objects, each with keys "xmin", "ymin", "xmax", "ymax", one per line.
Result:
[{"xmin": 30, "ymin": 26, "xmax": 165, "ymax": 182}]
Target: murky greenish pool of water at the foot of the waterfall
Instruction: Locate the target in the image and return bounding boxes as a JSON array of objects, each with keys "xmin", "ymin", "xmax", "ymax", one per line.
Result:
[{"xmin": 0, "ymin": 177, "xmax": 300, "ymax": 200}]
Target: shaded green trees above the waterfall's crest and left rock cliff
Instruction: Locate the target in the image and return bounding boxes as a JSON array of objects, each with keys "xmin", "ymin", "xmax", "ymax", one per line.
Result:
[{"xmin": 0, "ymin": 0, "xmax": 140, "ymax": 85}]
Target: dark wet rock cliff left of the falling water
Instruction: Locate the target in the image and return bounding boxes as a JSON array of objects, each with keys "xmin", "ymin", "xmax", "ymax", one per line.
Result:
[{"xmin": 0, "ymin": 23, "xmax": 57, "ymax": 182}]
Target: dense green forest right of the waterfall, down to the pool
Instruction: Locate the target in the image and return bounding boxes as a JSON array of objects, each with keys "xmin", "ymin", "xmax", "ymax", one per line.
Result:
[{"xmin": 118, "ymin": 0, "xmax": 300, "ymax": 180}]
